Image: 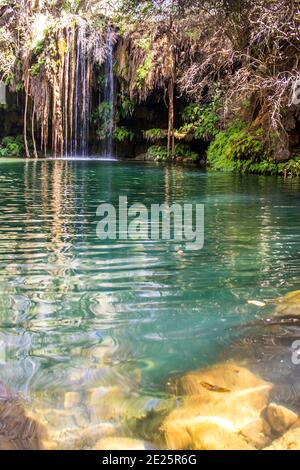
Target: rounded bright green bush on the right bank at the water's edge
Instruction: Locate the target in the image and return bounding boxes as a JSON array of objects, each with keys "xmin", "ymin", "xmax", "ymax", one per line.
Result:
[{"xmin": 207, "ymin": 122, "xmax": 273, "ymax": 173}]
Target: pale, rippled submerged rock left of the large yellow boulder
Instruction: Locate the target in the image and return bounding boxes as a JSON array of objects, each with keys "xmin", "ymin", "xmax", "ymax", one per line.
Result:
[{"xmin": 26, "ymin": 385, "xmax": 174, "ymax": 450}]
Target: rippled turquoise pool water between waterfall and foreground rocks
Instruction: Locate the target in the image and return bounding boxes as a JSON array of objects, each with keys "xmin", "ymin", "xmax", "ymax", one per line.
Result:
[{"xmin": 0, "ymin": 160, "xmax": 300, "ymax": 446}]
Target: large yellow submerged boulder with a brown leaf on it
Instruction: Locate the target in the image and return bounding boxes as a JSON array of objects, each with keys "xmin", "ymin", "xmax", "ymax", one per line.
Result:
[{"xmin": 161, "ymin": 363, "xmax": 272, "ymax": 450}]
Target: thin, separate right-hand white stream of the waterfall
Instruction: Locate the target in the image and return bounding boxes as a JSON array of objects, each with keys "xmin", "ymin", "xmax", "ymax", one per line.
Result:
[{"xmin": 104, "ymin": 27, "xmax": 114, "ymax": 157}]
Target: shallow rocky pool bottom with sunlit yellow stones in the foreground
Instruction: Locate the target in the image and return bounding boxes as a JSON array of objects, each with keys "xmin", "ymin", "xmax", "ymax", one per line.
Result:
[{"xmin": 0, "ymin": 291, "xmax": 300, "ymax": 450}]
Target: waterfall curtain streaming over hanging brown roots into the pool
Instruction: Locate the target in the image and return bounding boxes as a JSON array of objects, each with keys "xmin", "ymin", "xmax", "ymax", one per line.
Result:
[{"xmin": 49, "ymin": 21, "xmax": 115, "ymax": 159}]
